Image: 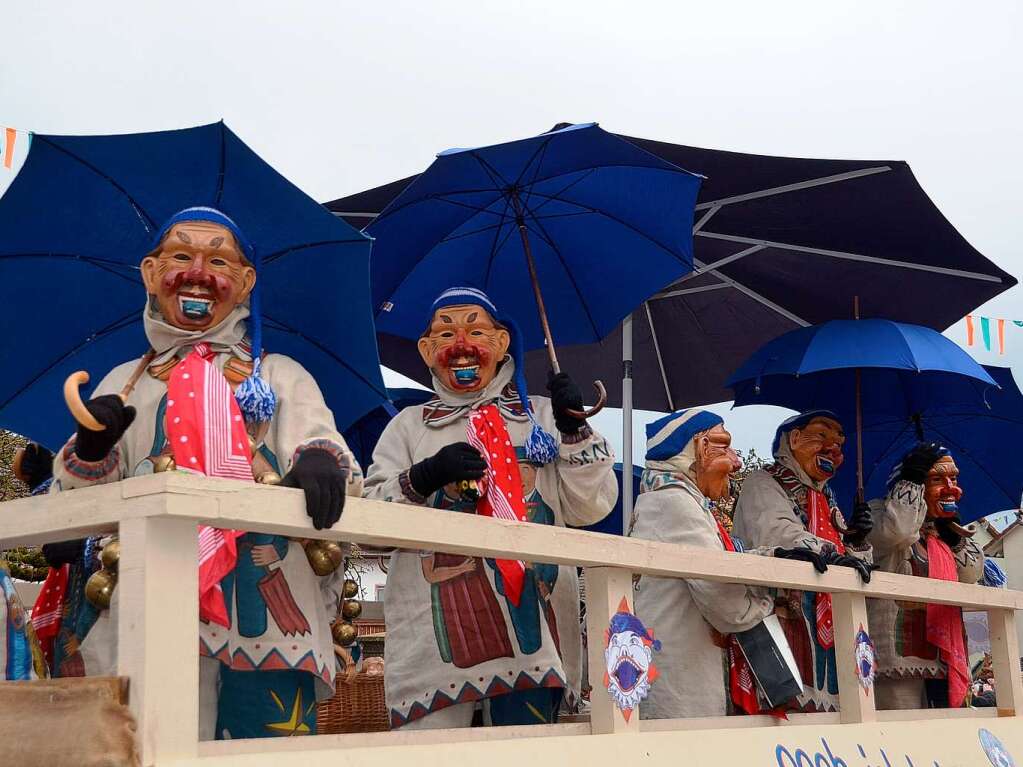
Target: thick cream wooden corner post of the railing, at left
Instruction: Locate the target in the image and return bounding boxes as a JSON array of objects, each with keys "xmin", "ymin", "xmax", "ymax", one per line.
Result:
[{"xmin": 118, "ymin": 516, "xmax": 198, "ymax": 767}]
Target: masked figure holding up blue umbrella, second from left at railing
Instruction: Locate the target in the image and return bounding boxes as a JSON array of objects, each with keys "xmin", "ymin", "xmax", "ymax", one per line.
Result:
[{"xmin": 366, "ymin": 287, "xmax": 617, "ymax": 728}]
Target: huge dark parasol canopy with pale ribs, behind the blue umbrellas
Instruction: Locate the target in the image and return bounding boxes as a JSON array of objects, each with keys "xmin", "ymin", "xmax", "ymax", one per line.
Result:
[{"xmin": 326, "ymin": 129, "xmax": 1017, "ymax": 411}]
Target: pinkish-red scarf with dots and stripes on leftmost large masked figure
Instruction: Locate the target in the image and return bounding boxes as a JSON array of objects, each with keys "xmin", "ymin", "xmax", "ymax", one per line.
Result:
[{"xmin": 167, "ymin": 344, "xmax": 253, "ymax": 627}]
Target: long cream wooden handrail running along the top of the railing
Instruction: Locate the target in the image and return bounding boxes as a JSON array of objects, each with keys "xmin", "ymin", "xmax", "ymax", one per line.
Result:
[{"xmin": 0, "ymin": 472, "xmax": 1023, "ymax": 610}]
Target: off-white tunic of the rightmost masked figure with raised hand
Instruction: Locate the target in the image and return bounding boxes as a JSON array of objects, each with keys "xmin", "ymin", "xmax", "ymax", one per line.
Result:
[{"xmin": 866, "ymin": 480, "xmax": 984, "ymax": 708}]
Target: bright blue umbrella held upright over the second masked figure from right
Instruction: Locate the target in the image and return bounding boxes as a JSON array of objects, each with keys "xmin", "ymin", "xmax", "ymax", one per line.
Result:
[{"xmin": 727, "ymin": 319, "xmax": 997, "ymax": 513}]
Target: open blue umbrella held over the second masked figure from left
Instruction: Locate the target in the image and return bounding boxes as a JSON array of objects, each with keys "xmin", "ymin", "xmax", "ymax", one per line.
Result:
[{"xmin": 366, "ymin": 123, "xmax": 700, "ymax": 417}]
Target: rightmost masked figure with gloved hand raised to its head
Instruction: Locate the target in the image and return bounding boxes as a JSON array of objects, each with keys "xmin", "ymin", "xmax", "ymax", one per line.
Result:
[{"xmin": 866, "ymin": 443, "xmax": 984, "ymax": 709}]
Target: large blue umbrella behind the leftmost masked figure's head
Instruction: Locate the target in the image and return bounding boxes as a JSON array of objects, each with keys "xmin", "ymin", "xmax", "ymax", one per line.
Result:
[{"xmin": 0, "ymin": 123, "xmax": 387, "ymax": 448}]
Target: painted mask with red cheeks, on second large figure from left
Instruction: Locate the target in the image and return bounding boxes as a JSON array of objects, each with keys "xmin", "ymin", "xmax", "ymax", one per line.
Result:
[{"xmin": 419, "ymin": 304, "xmax": 512, "ymax": 392}]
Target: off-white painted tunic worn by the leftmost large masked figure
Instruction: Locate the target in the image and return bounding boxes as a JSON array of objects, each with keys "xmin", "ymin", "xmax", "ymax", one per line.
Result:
[{"xmin": 51, "ymin": 307, "xmax": 362, "ymax": 697}]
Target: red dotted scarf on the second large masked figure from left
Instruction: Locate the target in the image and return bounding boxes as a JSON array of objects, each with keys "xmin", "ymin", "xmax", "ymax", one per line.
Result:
[{"xmin": 465, "ymin": 405, "xmax": 528, "ymax": 607}]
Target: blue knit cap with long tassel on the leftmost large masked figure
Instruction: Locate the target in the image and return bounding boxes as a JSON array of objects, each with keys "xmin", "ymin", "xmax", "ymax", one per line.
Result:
[{"xmin": 150, "ymin": 207, "xmax": 277, "ymax": 422}]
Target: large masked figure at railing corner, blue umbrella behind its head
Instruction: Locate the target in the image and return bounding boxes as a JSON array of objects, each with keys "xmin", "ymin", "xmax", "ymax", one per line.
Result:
[{"xmin": 46, "ymin": 208, "xmax": 362, "ymax": 738}]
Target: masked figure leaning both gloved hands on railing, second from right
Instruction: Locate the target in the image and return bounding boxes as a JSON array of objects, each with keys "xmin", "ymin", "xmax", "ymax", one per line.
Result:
[{"xmin": 732, "ymin": 410, "xmax": 874, "ymax": 712}]
